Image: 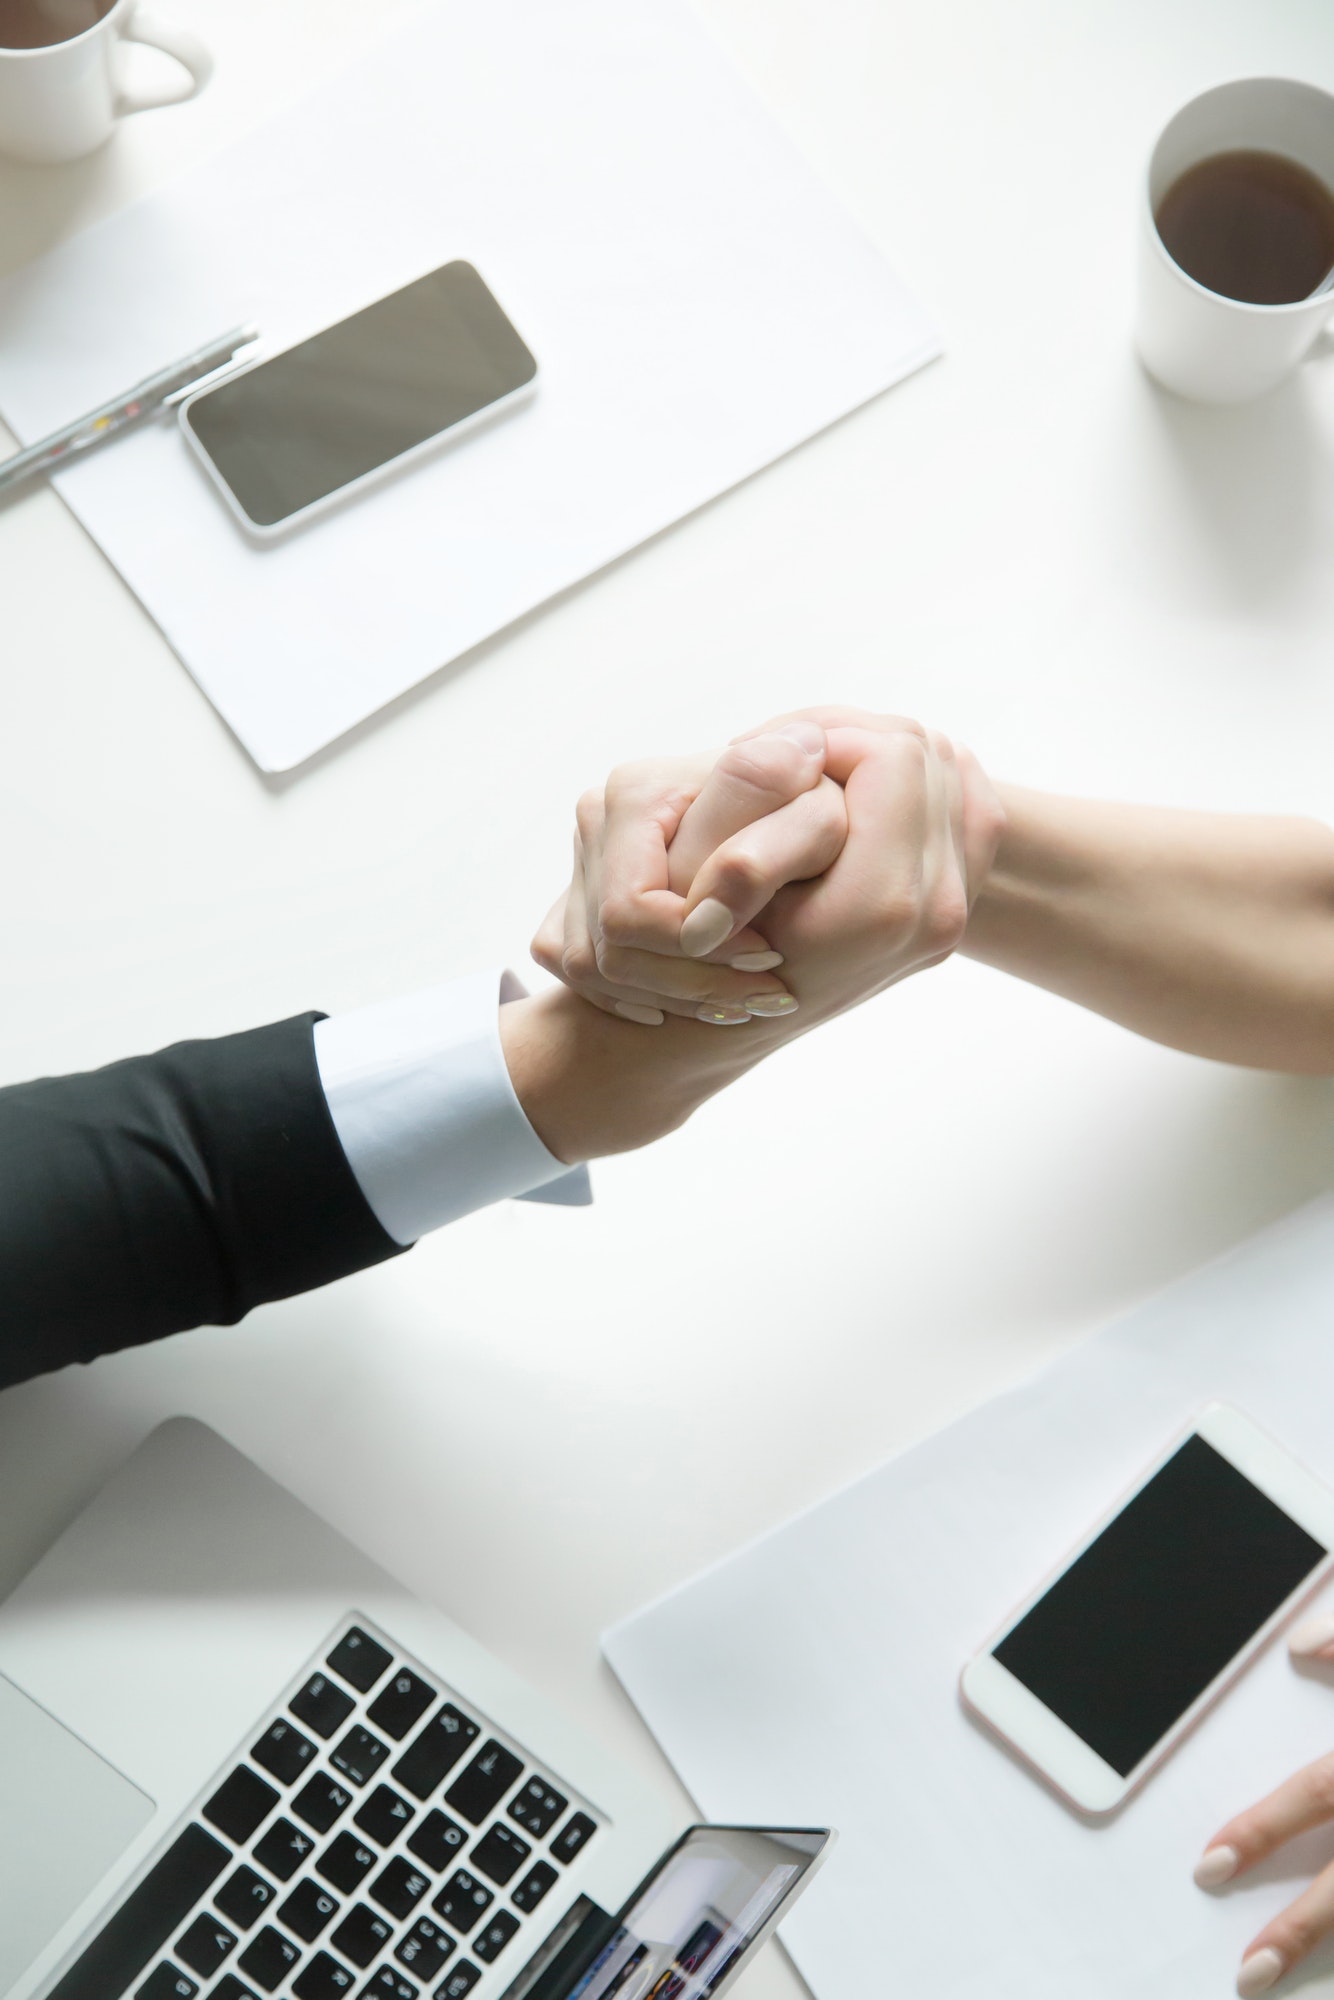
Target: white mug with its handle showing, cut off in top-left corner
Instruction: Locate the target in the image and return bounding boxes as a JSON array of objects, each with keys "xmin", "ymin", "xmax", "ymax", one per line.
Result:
[{"xmin": 0, "ymin": 0, "xmax": 212, "ymax": 164}]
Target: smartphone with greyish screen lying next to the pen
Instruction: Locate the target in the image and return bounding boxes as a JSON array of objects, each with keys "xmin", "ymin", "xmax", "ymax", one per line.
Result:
[{"xmin": 180, "ymin": 260, "xmax": 538, "ymax": 540}]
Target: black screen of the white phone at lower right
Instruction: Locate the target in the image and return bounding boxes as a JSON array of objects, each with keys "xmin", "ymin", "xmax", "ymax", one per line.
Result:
[{"xmin": 992, "ymin": 1436, "xmax": 1328, "ymax": 1778}]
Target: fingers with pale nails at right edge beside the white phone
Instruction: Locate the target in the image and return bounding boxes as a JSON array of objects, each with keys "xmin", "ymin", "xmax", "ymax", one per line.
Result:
[{"xmin": 1196, "ymin": 1616, "xmax": 1334, "ymax": 2000}]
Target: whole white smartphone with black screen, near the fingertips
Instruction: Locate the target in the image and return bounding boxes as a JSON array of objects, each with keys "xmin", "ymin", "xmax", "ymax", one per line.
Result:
[{"xmin": 960, "ymin": 1404, "xmax": 1334, "ymax": 1814}]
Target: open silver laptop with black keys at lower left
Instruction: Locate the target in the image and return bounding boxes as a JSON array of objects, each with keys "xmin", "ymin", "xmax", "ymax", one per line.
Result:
[{"xmin": 0, "ymin": 1418, "xmax": 832, "ymax": 2000}]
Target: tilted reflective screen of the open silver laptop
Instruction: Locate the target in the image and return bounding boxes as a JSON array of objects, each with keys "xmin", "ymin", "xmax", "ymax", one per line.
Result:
[{"xmin": 536, "ymin": 1826, "xmax": 834, "ymax": 2000}]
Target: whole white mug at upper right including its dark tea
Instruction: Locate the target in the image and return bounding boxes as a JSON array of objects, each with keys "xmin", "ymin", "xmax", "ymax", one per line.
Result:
[{"xmin": 1136, "ymin": 76, "xmax": 1334, "ymax": 402}]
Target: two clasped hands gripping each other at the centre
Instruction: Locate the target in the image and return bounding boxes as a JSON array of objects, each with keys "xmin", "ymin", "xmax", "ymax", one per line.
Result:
[{"xmin": 534, "ymin": 710, "xmax": 1004, "ymax": 1032}]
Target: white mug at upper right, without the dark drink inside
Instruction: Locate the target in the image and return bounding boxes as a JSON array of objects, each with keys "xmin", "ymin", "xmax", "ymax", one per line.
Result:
[{"xmin": 1136, "ymin": 76, "xmax": 1334, "ymax": 402}]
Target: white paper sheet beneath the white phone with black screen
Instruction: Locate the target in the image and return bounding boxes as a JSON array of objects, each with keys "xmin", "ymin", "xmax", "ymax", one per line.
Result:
[{"xmin": 606, "ymin": 1200, "xmax": 1334, "ymax": 2000}]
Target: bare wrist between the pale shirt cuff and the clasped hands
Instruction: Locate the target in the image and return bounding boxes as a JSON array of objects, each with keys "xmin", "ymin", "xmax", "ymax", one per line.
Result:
[{"xmin": 500, "ymin": 986, "xmax": 776, "ymax": 1166}]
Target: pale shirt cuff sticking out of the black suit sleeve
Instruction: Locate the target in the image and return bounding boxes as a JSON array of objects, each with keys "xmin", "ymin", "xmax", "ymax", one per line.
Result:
[{"xmin": 314, "ymin": 972, "xmax": 592, "ymax": 1244}]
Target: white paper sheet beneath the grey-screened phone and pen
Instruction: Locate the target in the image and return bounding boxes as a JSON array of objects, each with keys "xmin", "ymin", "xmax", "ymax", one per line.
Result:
[{"xmin": 0, "ymin": 0, "xmax": 938, "ymax": 770}]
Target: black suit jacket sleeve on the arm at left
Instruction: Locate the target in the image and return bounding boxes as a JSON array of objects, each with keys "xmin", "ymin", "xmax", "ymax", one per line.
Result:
[{"xmin": 0, "ymin": 1014, "xmax": 400, "ymax": 1386}]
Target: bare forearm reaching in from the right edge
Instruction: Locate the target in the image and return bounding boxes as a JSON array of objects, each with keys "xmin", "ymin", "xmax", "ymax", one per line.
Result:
[{"xmin": 962, "ymin": 788, "xmax": 1334, "ymax": 1076}]
